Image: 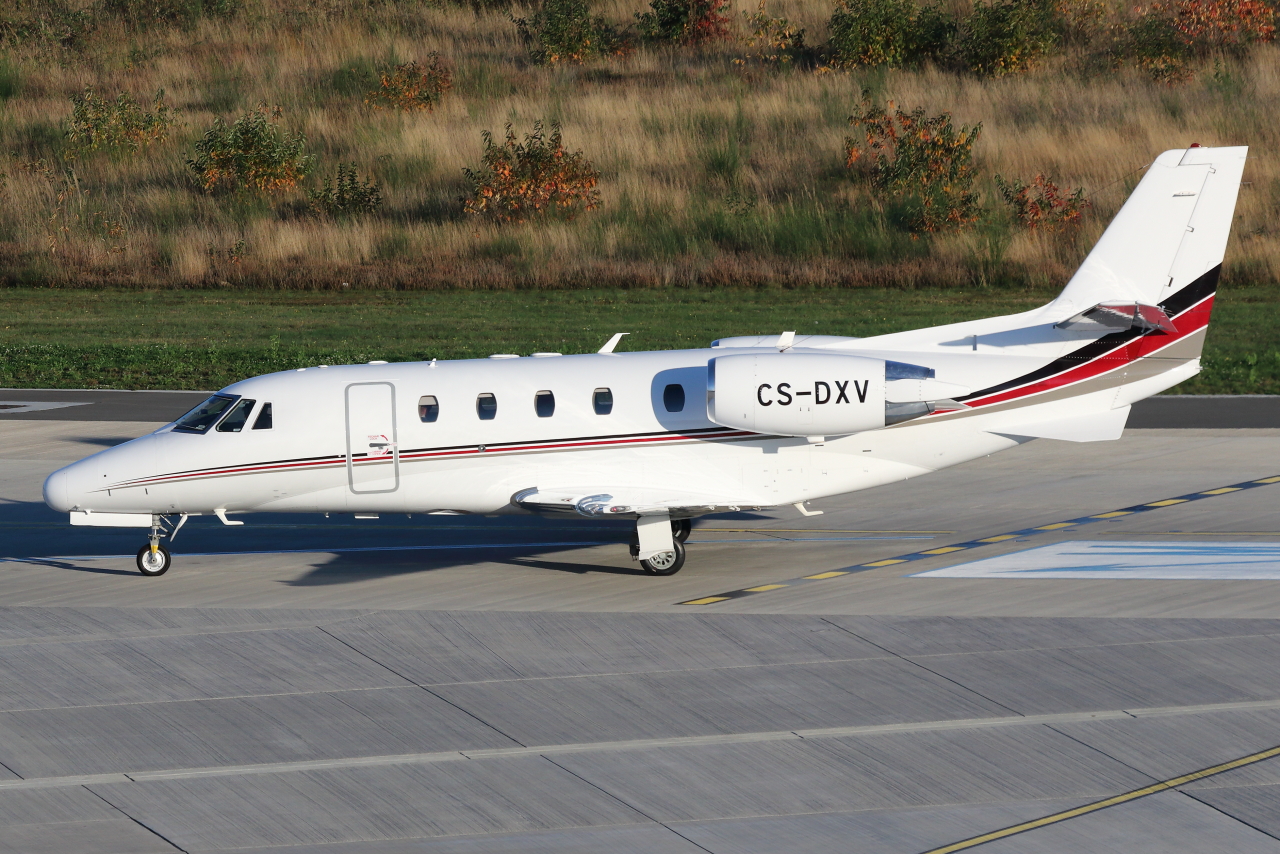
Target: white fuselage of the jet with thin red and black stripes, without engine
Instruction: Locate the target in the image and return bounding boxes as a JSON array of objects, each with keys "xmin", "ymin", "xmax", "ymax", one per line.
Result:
[{"xmin": 37, "ymin": 312, "xmax": 1198, "ymax": 515}]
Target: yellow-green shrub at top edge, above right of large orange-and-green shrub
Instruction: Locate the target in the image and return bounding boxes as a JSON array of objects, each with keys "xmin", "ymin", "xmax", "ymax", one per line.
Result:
[{"xmin": 956, "ymin": 0, "xmax": 1057, "ymax": 77}]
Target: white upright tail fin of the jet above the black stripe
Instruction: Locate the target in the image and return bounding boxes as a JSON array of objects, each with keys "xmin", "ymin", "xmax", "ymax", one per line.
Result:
[{"xmin": 1055, "ymin": 146, "xmax": 1248, "ymax": 316}]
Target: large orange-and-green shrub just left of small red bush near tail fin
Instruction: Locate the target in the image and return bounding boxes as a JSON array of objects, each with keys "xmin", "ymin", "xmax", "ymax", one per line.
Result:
[{"xmin": 845, "ymin": 101, "xmax": 982, "ymax": 232}]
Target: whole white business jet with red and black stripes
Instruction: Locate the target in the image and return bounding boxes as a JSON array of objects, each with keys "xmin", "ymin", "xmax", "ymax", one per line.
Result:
[{"xmin": 44, "ymin": 146, "xmax": 1247, "ymax": 576}]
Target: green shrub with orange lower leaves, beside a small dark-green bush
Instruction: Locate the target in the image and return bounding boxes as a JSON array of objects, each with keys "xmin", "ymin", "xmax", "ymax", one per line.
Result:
[{"xmin": 187, "ymin": 109, "xmax": 315, "ymax": 192}]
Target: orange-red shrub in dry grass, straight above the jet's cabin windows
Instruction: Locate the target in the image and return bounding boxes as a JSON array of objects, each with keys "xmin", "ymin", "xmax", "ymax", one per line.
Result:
[{"xmin": 463, "ymin": 122, "xmax": 600, "ymax": 223}]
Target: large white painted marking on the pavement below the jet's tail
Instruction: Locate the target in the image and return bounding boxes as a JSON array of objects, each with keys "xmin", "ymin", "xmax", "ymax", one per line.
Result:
[{"xmin": 913, "ymin": 540, "xmax": 1280, "ymax": 581}]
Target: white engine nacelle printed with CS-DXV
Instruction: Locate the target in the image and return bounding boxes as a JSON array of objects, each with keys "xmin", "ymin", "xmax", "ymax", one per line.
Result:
[{"xmin": 707, "ymin": 352, "xmax": 890, "ymax": 437}]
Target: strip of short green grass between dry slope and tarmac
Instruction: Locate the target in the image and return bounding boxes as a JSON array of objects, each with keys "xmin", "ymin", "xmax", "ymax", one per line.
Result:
[{"xmin": 0, "ymin": 286, "xmax": 1280, "ymax": 394}]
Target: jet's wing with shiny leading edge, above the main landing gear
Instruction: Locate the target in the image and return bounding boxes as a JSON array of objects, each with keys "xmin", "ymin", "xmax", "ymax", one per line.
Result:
[{"xmin": 511, "ymin": 485, "xmax": 767, "ymax": 519}]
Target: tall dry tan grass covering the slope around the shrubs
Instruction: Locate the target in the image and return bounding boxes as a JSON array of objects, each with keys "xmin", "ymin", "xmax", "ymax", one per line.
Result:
[{"xmin": 0, "ymin": 0, "xmax": 1280, "ymax": 288}]
